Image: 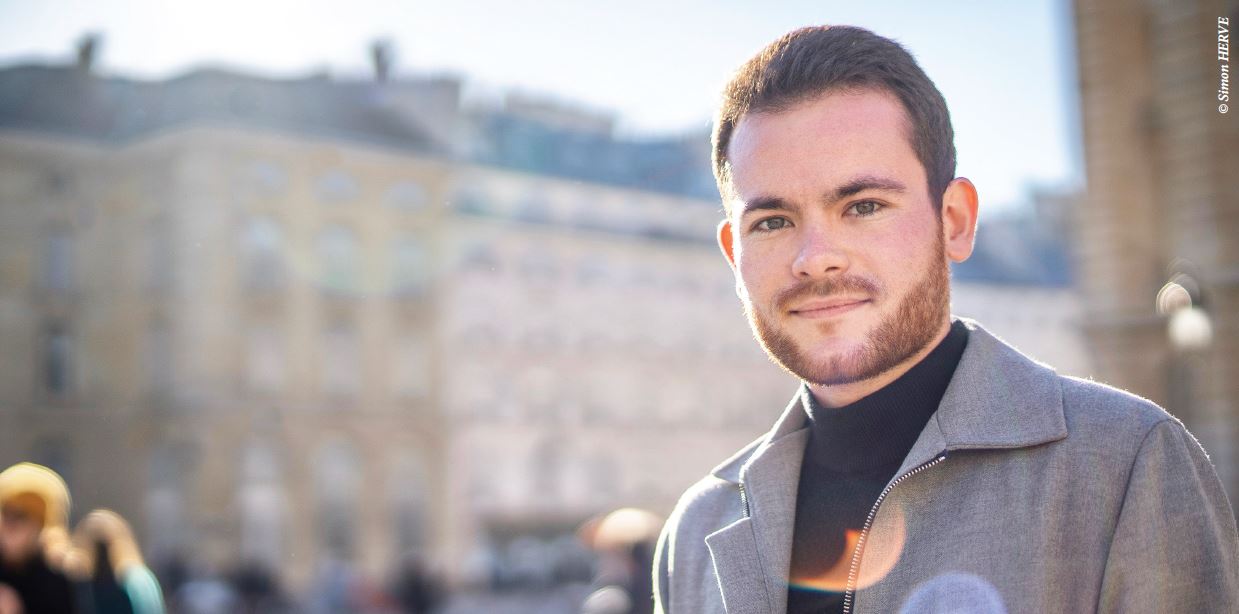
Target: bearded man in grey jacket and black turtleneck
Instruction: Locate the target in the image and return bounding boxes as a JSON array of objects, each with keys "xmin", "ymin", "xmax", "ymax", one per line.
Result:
[{"xmin": 654, "ymin": 27, "xmax": 1239, "ymax": 614}]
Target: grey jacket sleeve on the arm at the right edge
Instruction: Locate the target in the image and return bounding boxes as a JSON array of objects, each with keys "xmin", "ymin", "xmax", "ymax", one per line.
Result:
[{"xmin": 1098, "ymin": 418, "xmax": 1239, "ymax": 613}]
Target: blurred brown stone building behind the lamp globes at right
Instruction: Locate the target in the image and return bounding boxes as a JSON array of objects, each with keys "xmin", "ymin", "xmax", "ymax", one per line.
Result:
[{"xmin": 1074, "ymin": 0, "xmax": 1239, "ymax": 501}]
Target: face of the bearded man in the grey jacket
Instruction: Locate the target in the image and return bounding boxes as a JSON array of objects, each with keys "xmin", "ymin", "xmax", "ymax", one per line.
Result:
[{"xmin": 720, "ymin": 90, "xmax": 950, "ymax": 386}]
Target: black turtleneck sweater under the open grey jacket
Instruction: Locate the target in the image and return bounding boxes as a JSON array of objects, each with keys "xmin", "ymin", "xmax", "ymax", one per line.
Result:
[{"xmin": 787, "ymin": 321, "xmax": 968, "ymax": 614}]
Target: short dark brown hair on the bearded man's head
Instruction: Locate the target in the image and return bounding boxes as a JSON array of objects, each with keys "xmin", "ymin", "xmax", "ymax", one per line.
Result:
[{"xmin": 711, "ymin": 26, "xmax": 955, "ymax": 210}]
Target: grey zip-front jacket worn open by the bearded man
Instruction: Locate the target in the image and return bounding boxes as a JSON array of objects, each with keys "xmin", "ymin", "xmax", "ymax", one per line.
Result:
[{"xmin": 654, "ymin": 319, "xmax": 1239, "ymax": 614}]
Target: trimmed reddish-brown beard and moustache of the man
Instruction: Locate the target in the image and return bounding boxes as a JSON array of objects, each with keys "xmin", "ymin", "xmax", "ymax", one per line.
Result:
[{"xmin": 742, "ymin": 231, "xmax": 950, "ymax": 386}]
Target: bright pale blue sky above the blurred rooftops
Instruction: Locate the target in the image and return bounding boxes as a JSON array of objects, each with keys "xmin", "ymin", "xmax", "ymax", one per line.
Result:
[{"xmin": 0, "ymin": 0, "xmax": 1083, "ymax": 208}]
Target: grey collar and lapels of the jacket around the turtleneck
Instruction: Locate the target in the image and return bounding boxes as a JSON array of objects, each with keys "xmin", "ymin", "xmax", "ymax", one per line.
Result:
[{"xmin": 706, "ymin": 318, "xmax": 1067, "ymax": 612}]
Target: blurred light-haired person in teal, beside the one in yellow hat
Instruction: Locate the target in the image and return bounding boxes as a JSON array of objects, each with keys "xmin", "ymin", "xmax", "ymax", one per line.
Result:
[{"xmin": 66, "ymin": 510, "xmax": 166, "ymax": 614}]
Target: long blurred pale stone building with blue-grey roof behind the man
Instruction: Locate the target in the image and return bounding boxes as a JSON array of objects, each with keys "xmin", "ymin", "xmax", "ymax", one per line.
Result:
[{"xmin": 0, "ymin": 37, "xmax": 1089, "ymax": 590}]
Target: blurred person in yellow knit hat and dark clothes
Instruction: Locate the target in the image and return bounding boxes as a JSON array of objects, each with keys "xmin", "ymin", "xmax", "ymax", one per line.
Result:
[{"xmin": 0, "ymin": 463, "xmax": 77, "ymax": 614}]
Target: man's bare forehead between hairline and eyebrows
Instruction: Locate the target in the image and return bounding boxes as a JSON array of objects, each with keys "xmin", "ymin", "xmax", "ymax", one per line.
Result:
[{"xmin": 727, "ymin": 90, "xmax": 927, "ymax": 196}]
